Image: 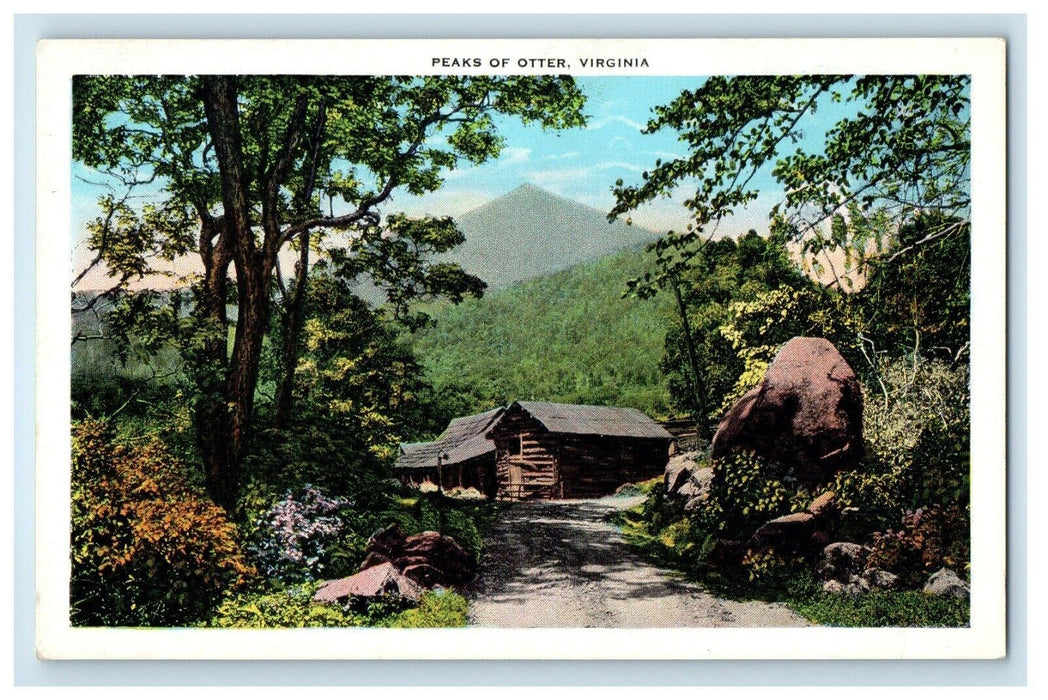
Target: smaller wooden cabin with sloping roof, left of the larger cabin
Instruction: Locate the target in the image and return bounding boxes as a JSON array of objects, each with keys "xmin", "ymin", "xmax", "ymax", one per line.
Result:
[{"xmin": 393, "ymin": 408, "xmax": 503, "ymax": 498}]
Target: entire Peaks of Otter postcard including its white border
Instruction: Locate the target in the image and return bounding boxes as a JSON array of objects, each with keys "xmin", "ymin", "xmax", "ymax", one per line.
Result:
[{"xmin": 36, "ymin": 38, "xmax": 1006, "ymax": 659}]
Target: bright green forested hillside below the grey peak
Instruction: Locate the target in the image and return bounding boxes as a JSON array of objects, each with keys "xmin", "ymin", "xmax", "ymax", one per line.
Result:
[{"xmin": 414, "ymin": 249, "xmax": 673, "ymax": 417}]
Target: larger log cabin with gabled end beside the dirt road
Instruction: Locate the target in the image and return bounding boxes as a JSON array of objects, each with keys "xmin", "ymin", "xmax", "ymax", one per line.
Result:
[{"xmin": 486, "ymin": 401, "xmax": 673, "ymax": 500}]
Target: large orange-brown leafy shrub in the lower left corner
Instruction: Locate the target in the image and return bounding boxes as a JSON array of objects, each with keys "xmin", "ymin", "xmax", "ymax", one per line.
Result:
[{"xmin": 69, "ymin": 419, "xmax": 255, "ymax": 626}]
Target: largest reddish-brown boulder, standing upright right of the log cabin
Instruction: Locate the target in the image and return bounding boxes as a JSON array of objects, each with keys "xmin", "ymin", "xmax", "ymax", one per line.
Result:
[{"xmin": 711, "ymin": 337, "xmax": 863, "ymax": 485}]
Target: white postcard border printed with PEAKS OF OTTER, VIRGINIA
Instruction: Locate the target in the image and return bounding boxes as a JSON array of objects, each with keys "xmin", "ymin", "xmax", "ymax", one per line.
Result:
[{"xmin": 36, "ymin": 38, "xmax": 1006, "ymax": 659}]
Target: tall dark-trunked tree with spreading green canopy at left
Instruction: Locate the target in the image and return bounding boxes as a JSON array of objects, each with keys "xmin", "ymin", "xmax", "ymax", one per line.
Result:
[{"xmin": 73, "ymin": 75, "xmax": 583, "ymax": 507}]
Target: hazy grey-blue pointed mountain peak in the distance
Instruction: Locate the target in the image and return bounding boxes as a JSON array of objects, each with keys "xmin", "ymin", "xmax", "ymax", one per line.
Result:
[{"xmin": 442, "ymin": 184, "xmax": 657, "ymax": 289}]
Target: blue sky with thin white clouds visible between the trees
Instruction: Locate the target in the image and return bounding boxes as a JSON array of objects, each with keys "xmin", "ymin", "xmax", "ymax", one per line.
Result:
[{"xmin": 71, "ymin": 76, "xmax": 839, "ymax": 287}]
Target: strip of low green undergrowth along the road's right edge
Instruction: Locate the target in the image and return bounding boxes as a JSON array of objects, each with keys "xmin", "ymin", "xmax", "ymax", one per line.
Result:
[{"xmin": 609, "ymin": 496, "xmax": 969, "ymax": 627}]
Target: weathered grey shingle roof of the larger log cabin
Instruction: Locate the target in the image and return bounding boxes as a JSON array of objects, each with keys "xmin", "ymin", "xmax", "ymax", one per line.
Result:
[{"xmin": 507, "ymin": 401, "xmax": 673, "ymax": 440}]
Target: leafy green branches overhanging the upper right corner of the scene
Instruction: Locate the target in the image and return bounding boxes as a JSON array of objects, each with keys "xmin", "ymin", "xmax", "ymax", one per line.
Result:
[{"xmin": 611, "ymin": 75, "xmax": 970, "ymax": 274}]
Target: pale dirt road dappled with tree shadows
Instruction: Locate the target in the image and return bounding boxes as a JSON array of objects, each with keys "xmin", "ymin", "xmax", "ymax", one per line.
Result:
[{"xmin": 470, "ymin": 498, "xmax": 806, "ymax": 628}]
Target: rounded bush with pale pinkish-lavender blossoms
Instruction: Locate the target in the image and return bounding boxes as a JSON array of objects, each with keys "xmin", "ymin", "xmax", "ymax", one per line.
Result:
[{"xmin": 248, "ymin": 484, "xmax": 351, "ymax": 584}]
